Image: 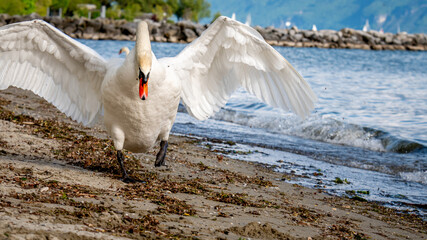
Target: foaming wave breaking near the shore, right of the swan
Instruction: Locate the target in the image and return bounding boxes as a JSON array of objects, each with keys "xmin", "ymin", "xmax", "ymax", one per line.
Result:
[{"xmin": 209, "ymin": 106, "xmax": 427, "ymax": 153}]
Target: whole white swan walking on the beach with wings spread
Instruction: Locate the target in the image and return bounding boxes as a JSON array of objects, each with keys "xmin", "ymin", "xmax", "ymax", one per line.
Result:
[{"xmin": 0, "ymin": 17, "xmax": 316, "ymax": 181}]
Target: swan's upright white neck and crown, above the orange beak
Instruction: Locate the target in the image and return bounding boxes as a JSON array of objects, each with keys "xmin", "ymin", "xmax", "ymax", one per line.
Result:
[{"xmin": 135, "ymin": 21, "xmax": 152, "ymax": 73}]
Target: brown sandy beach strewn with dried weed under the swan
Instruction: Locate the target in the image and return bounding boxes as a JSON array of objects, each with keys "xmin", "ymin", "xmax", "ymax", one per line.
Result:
[{"xmin": 0, "ymin": 88, "xmax": 427, "ymax": 239}]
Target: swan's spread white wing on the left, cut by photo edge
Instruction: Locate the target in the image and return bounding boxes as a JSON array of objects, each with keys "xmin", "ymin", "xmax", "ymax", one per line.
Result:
[{"xmin": 0, "ymin": 20, "xmax": 106, "ymax": 125}]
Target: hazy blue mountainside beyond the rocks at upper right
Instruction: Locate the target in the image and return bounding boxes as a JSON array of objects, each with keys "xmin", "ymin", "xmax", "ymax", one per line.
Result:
[{"xmin": 209, "ymin": 0, "xmax": 427, "ymax": 33}]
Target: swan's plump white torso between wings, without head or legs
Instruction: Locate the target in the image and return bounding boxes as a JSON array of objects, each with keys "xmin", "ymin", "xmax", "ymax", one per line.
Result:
[{"xmin": 102, "ymin": 51, "xmax": 181, "ymax": 152}]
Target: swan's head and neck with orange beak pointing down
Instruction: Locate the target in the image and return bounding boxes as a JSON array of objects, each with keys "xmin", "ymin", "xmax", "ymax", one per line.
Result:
[{"xmin": 135, "ymin": 21, "xmax": 152, "ymax": 100}]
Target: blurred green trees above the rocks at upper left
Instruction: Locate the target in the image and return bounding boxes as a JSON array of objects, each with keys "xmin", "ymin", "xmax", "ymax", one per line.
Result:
[{"xmin": 0, "ymin": 0, "xmax": 214, "ymax": 22}]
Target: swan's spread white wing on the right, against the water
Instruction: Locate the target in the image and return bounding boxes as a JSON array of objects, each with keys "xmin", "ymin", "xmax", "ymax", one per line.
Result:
[{"xmin": 171, "ymin": 17, "xmax": 316, "ymax": 119}]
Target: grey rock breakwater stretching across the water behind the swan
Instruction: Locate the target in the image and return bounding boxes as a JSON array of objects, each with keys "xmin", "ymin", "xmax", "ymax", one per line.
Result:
[{"xmin": 0, "ymin": 14, "xmax": 427, "ymax": 51}]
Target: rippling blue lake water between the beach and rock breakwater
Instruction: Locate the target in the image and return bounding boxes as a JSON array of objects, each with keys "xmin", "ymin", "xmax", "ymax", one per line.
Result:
[{"xmin": 79, "ymin": 40, "xmax": 427, "ymax": 217}]
